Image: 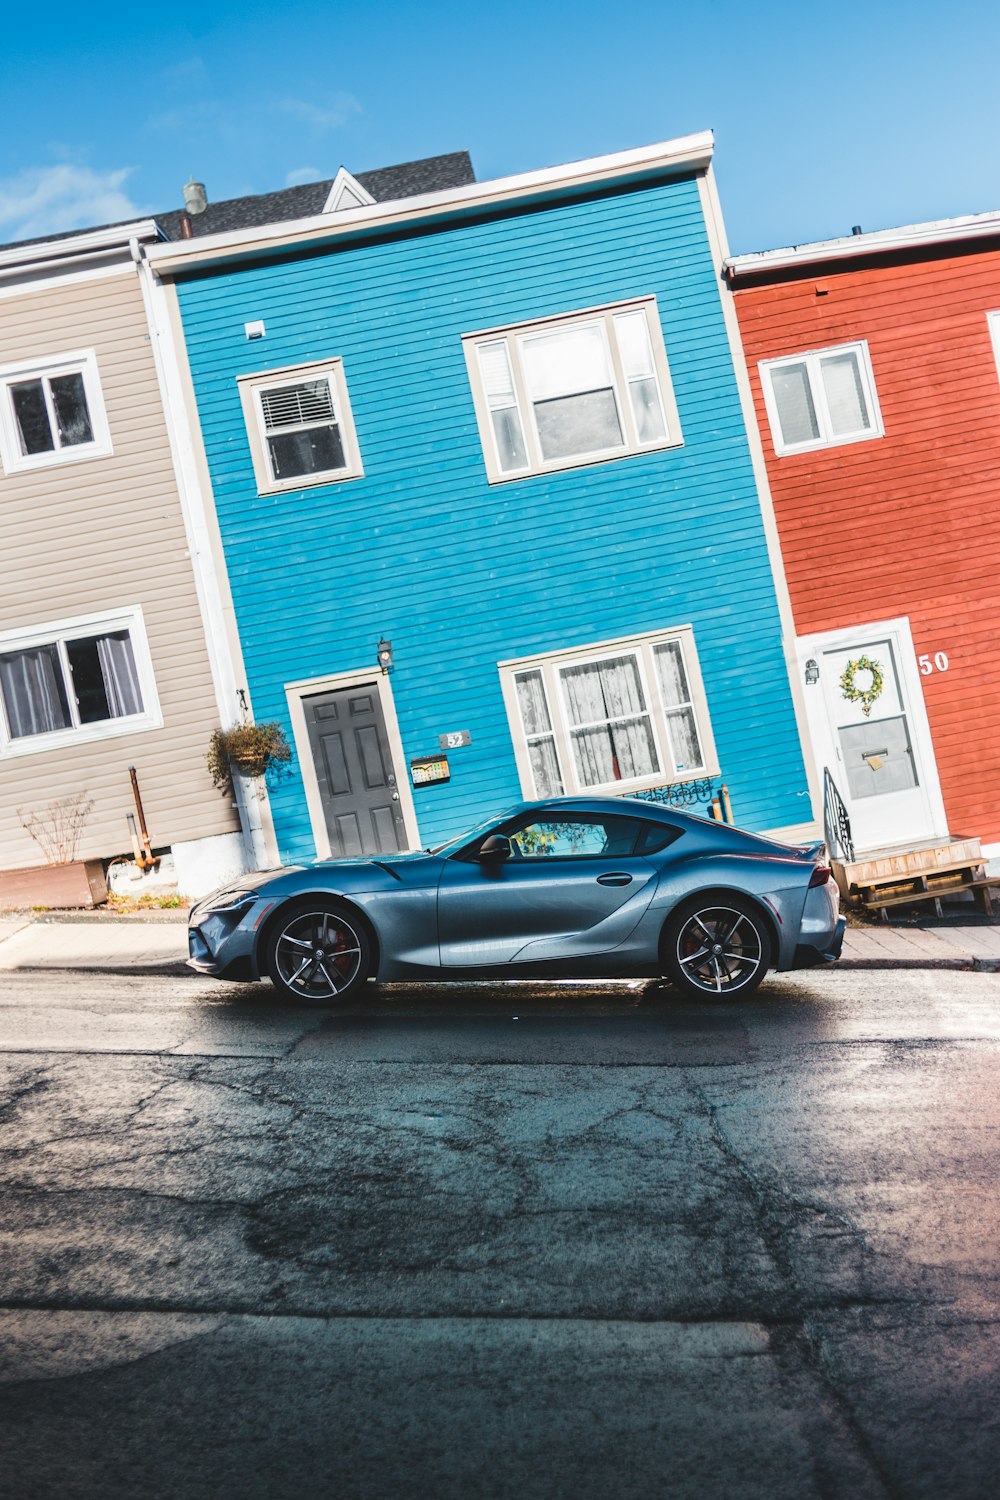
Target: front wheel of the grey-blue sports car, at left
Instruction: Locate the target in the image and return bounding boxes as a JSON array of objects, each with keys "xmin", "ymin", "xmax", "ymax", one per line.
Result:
[{"xmin": 264, "ymin": 897, "xmax": 372, "ymax": 1005}]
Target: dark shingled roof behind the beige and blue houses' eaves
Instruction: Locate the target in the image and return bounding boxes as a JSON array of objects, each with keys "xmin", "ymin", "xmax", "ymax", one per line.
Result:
[{"xmin": 1, "ymin": 152, "xmax": 475, "ymax": 249}]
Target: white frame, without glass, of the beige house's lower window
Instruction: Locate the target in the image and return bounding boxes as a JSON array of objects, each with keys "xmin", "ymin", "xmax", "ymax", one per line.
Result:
[{"xmin": 0, "ymin": 605, "xmax": 163, "ymax": 759}]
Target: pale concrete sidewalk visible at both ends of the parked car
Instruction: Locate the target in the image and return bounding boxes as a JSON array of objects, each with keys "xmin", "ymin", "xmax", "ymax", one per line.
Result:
[{"xmin": 0, "ymin": 912, "xmax": 1000, "ymax": 972}]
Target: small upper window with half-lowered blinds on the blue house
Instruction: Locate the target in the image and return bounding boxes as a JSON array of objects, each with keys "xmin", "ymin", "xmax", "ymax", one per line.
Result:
[{"xmin": 240, "ymin": 360, "xmax": 364, "ymax": 494}]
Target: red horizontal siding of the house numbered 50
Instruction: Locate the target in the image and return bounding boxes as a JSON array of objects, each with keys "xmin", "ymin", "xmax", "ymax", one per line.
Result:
[{"xmin": 736, "ymin": 251, "xmax": 1000, "ymax": 843}]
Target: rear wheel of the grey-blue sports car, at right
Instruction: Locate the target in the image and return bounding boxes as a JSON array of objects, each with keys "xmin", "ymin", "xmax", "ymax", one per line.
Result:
[{"xmin": 661, "ymin": 896, "xmax": 774, "ymax": 1001}]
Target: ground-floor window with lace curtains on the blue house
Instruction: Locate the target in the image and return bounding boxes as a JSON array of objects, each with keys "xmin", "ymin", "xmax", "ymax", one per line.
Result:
[{"xmin": 501, "ymin": 626, "xmax": 718, "ymax": 797}]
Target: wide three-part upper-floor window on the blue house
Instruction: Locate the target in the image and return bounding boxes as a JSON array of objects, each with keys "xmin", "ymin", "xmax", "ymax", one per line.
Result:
[{"xmin": 463, "ymin": 297, "xmax": 682, "ymax": 483}]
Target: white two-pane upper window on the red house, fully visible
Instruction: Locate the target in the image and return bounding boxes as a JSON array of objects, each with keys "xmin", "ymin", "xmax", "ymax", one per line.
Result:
[{"xmin": 760, "ymin": 342, "xmax": 885, "ymax": 453}]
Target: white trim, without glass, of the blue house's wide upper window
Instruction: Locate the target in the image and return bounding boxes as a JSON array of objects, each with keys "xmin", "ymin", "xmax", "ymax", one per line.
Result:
[{"xmin": 462, "ymin": 296, "xmax": 684, "ymax": 485}]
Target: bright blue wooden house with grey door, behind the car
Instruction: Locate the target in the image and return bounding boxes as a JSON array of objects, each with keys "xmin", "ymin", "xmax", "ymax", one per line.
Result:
[{"xmin": 147, "ymin": 135, "xmax": 814, "ymax": 860}]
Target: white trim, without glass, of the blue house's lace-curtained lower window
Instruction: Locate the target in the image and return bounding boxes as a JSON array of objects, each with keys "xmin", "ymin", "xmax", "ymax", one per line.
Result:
[{"xmin": 498, "ymin": 626, "xmax": 720, "ymax": 801}]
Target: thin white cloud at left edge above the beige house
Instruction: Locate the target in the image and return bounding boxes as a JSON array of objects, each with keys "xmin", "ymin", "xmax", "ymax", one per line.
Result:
[{"xmin": 0, "ymin": 162, "xmax": 139, "ymax": 240}]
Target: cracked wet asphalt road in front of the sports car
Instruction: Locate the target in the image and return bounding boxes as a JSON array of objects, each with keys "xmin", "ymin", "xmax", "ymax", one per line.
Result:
[{"xmin": 0, "ymin": 971, "xmax": 1000, "ymax": 1500}]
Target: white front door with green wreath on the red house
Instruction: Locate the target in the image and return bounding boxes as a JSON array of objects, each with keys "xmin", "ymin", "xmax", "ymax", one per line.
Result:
[{"xmin": 799, "ymin": 618, "xmax": 948, "ymax": 854}]
